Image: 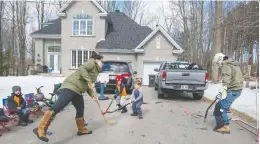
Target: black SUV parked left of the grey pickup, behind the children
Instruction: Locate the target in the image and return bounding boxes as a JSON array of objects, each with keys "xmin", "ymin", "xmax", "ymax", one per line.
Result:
[{"xmin": 95, "ymin": 61, "xmax": 137, "ymax": 93}]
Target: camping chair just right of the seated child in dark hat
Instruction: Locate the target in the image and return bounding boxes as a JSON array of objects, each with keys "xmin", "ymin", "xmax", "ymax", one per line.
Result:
[{"xmin": 24, "ymin": 93, "xmax": 43, "ymax": 116}]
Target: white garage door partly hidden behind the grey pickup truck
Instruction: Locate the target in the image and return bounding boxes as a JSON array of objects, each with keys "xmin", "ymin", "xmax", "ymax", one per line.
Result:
[{"xmin": 143, "ymin": 62, "xmax": 161, "ymax": 85}]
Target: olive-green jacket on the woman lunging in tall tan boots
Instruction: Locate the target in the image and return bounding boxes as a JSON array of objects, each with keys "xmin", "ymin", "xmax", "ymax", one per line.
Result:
[{"xmin": 60, "ymin": 59, "xmax": 101, "ymax": 97}]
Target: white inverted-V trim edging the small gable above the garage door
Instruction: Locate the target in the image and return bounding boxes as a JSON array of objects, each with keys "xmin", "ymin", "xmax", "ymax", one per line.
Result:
[{"xmin": 134, "ymin": 25, "xmax": 183, "ymax": 53}]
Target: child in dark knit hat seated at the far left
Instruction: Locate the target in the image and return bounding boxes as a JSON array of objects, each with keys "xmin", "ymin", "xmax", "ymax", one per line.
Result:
[{"xmin": 11, "ymin": 86, "xmax": 33, "ymax": 126}]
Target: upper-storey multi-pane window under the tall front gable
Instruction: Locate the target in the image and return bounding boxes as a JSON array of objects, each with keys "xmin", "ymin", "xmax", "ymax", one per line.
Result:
[{"xmin": 73, "ymin": 14, "xmax": 93, "ymax": 36}]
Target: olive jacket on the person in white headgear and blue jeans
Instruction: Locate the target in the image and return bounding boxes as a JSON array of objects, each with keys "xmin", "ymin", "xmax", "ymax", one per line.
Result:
[{"xmin": 221, "ymin": 59, "xmax": 244, "ymax": 90}]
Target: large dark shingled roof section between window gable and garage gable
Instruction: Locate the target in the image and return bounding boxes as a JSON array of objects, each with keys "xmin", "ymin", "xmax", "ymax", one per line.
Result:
[{"xmin": 96, "ymin": 12, "xmax": 152, "ymax": 50}]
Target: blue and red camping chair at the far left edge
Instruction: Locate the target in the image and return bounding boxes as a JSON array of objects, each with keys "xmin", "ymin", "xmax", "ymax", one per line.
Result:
[{"xmin": 2, "ymin": 98, "xmax": 18, "ymax": 125}]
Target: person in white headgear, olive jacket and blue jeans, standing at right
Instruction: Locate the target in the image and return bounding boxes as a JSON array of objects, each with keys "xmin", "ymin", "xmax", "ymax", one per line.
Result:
[{"xmin": 213, "ymin": 53, "xmax": 243, "ymax": 133}]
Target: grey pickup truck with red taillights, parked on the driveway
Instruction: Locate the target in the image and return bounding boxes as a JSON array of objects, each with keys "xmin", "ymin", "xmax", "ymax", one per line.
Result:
[{"xmin": 154, "ymin": 61, "xmax": 209, "ymax": 100}]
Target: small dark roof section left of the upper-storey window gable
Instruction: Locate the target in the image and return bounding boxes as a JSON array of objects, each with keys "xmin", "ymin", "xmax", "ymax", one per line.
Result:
[{"xmin": 31, "ymin": 18, "xmax": 61, "ymax": 35}]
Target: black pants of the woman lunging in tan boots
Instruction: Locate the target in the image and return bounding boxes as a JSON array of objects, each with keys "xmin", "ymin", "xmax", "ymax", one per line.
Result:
[{"xmin": 51, "ymin": 89, "xmax": 84, "ymax": 118}]
